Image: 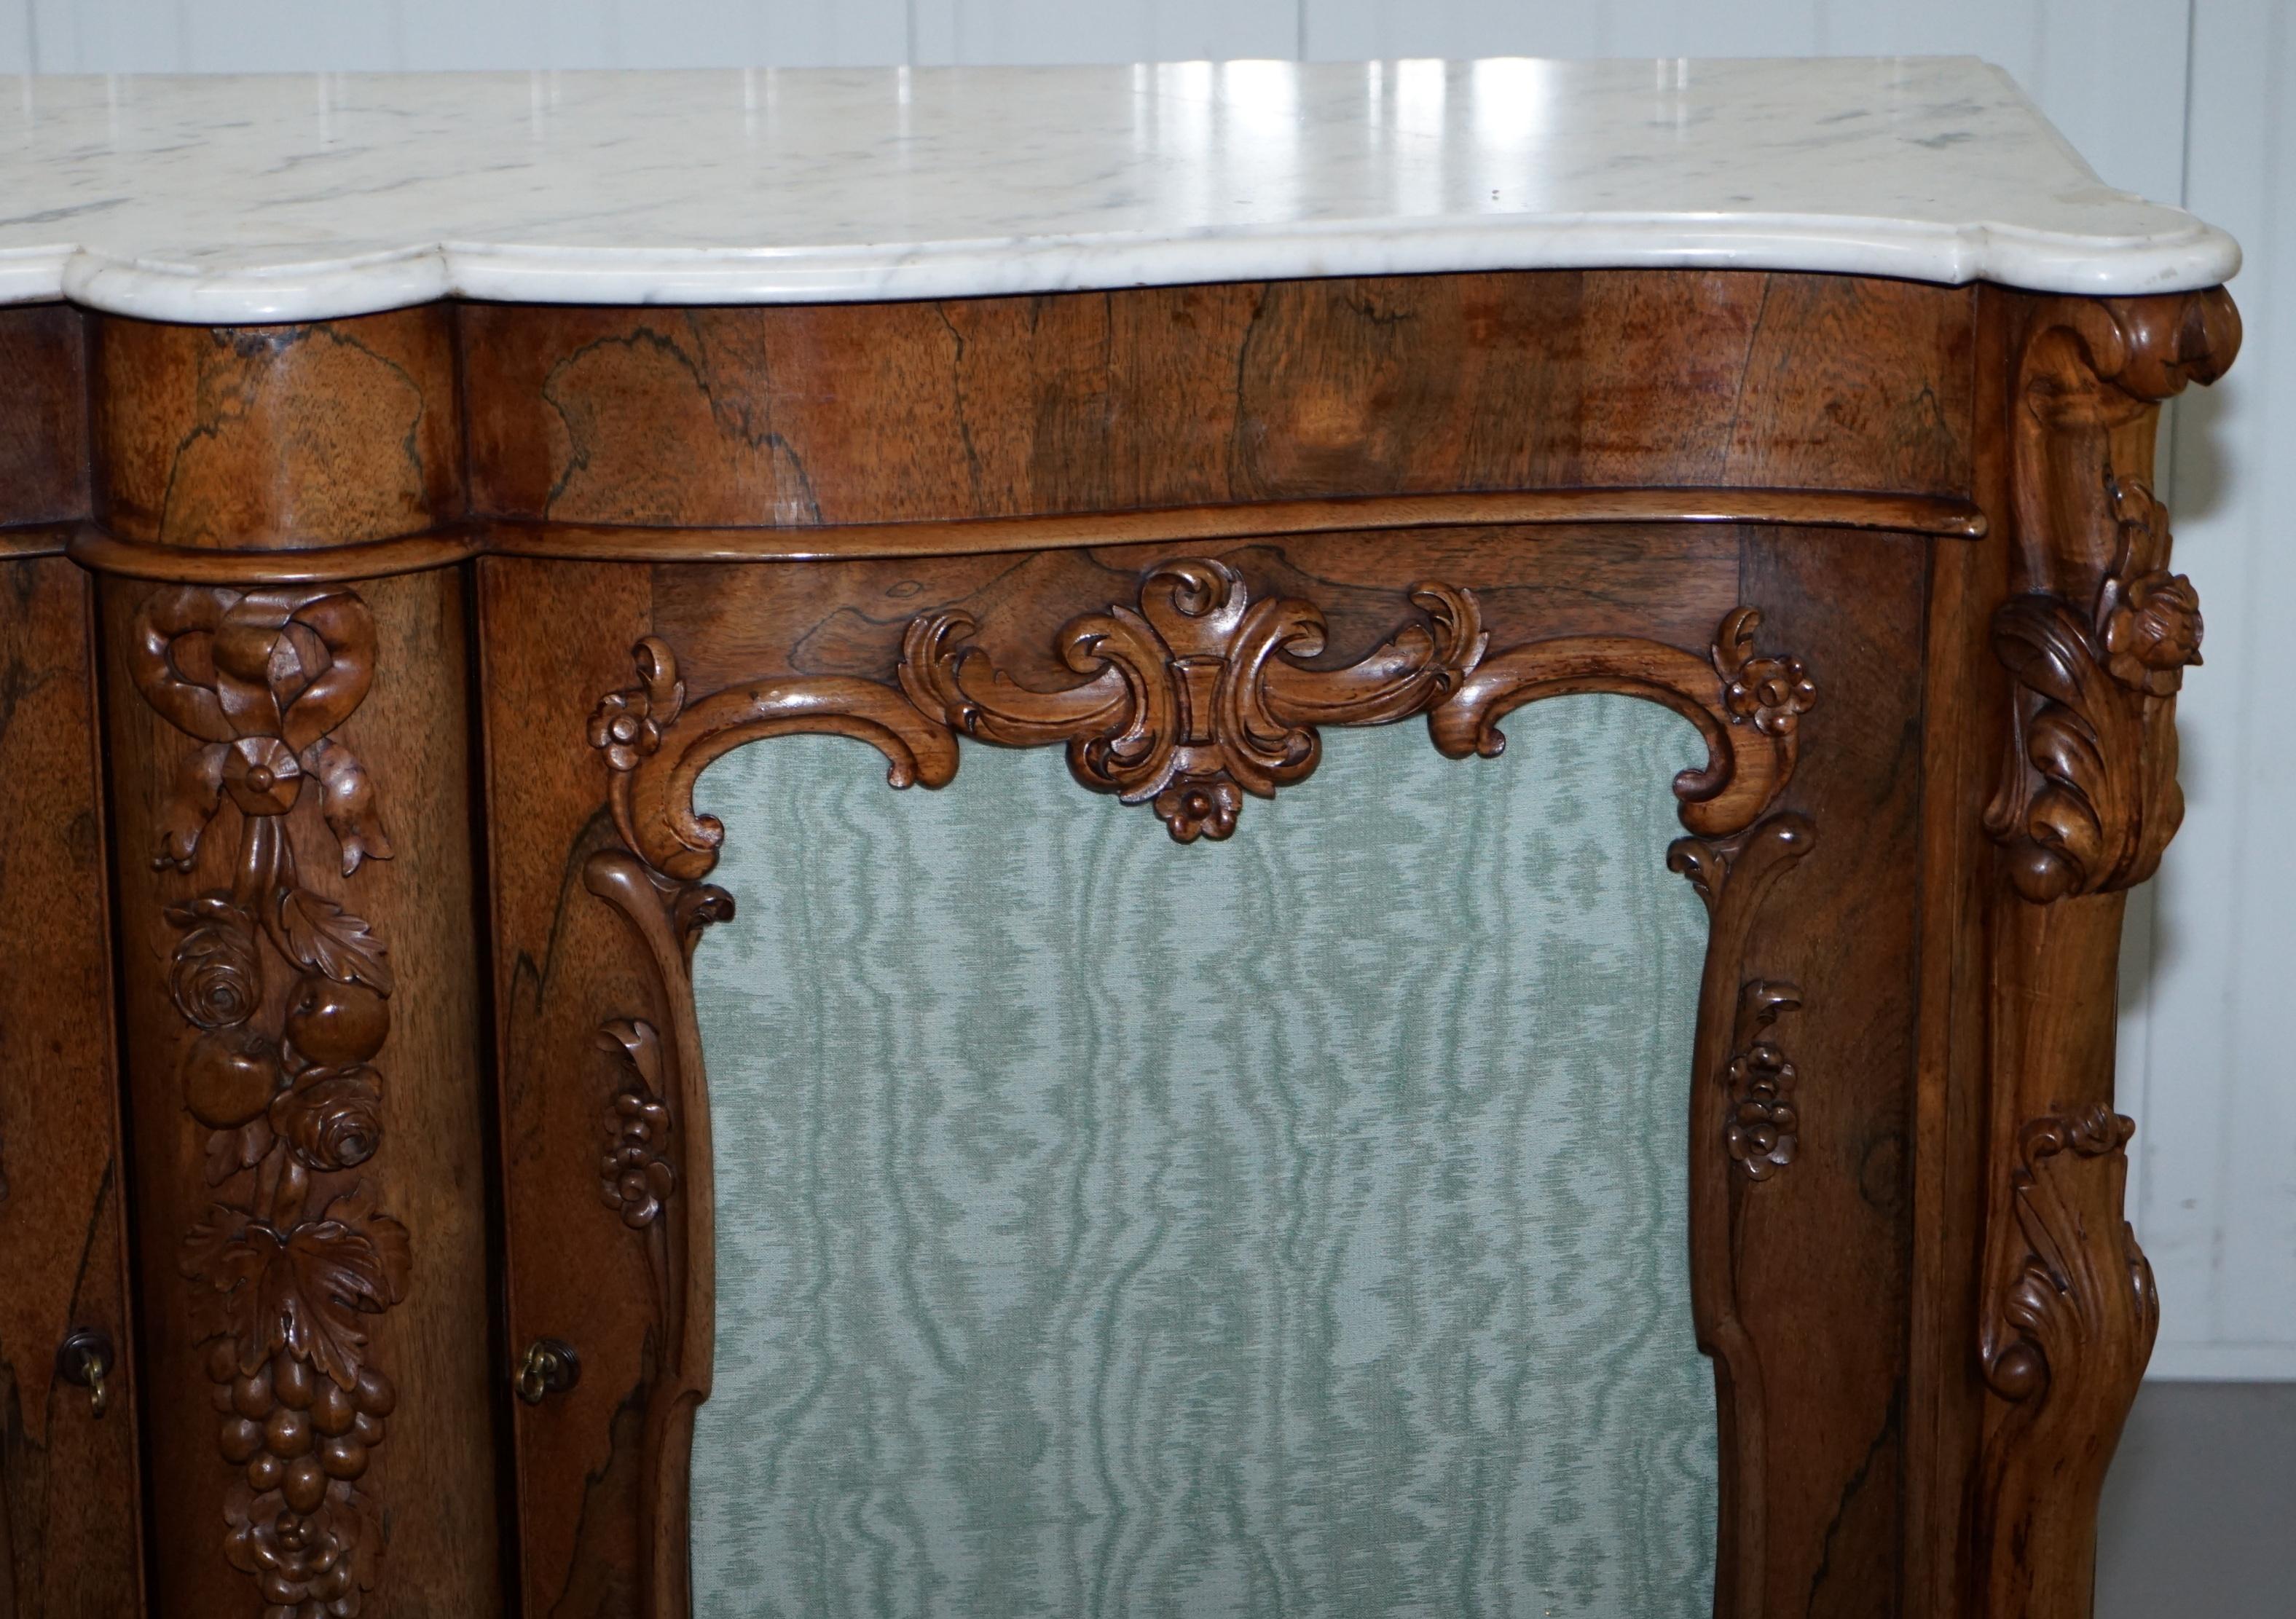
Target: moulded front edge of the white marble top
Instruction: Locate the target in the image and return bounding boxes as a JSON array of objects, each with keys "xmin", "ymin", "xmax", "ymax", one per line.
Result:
[{"xmin": 0, "ymin": 213, "xmax": 2241, "ymax": 326}]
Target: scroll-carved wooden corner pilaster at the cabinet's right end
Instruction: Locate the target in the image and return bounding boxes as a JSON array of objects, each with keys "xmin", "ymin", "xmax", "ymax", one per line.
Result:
[{"xmin": 1967, "ymin": 287, "xmax": 2241, "ymax": 1619}]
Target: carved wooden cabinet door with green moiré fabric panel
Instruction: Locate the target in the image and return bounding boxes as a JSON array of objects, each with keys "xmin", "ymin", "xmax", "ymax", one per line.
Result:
[{"xmin": 480, "ymin": 524, "xmax": 1933, "ymax": 1619}]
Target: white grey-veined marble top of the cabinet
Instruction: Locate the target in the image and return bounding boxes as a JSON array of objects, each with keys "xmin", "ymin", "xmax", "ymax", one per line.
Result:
[{"xmin": 0, "ymin": 58, "xmax": 2238, "ymax": 324}]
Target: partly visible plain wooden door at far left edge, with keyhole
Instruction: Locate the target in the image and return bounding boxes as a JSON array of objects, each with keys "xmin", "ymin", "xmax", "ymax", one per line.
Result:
[{"xmin": 0, "ymin": 556, "xmax": 142, "ymax": 1619}]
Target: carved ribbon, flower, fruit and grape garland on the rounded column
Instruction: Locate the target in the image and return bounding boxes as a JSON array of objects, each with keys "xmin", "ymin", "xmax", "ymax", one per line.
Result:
[{"xmin": 129, "ymin": 586, "xmax": 411, "ymax": 1617}]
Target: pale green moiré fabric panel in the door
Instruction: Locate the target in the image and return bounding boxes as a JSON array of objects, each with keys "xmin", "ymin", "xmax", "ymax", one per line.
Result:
[{"xmin": 693, "ymin": 696, "xmax": 1715, "ymax": 1619}]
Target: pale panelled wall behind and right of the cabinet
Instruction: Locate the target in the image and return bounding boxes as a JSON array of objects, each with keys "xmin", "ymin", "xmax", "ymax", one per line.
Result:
[{"xmin": 0, "ymin": 0, "xmax": 2296, "ymax": 1380}]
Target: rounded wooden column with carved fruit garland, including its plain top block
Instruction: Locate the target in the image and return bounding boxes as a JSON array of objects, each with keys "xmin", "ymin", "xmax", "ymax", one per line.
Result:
[{"xmin": 89, "ymin": 305, "xmax": 500, "ymax": 1619}]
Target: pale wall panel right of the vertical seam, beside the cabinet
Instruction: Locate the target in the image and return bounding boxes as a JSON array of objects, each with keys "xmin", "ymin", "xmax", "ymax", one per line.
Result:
[{"xmin": 2138, "ymin": 0, "xmax": 2296, "ymax": 1378}]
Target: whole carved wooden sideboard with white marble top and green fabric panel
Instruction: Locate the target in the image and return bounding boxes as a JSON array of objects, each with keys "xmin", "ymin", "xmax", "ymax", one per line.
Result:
[{"xmin": 0, "ymin": 62, "xmax": 2238, "ymax": 1619}]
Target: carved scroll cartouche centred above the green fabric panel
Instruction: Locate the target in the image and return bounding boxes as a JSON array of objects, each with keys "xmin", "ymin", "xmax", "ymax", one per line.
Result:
[{"xmin": 897, "ymin": 558, "xmax": 1485, "ymax": 843}]
